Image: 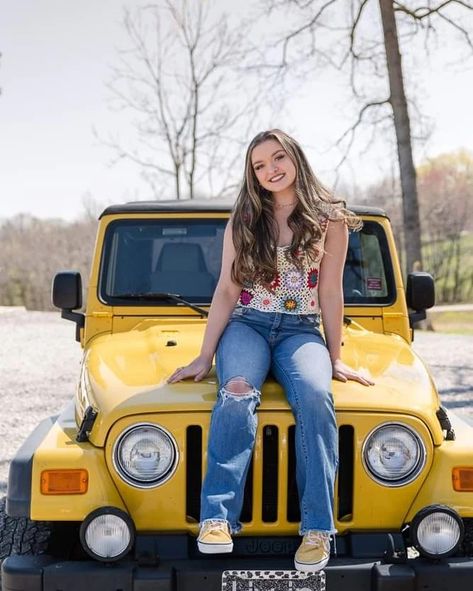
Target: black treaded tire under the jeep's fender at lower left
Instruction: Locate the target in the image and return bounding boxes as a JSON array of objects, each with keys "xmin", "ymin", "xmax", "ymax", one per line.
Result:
[{"xmin": 0, "ymin": 497, "xmax": 51, "ymax": 591}]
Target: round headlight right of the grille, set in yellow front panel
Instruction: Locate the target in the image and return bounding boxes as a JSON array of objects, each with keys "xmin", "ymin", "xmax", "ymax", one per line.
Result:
[{"xmin": 363, "ymin": 423, "xmax": 426, "ymax": 486}]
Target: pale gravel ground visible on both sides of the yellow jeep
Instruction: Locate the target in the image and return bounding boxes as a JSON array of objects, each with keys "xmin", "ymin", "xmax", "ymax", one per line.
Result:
[{"xmin": 0, "ymin": 307, "xmax": 473, "ymax": 494}]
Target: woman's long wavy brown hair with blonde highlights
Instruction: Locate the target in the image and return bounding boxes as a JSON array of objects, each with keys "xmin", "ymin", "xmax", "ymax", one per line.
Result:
[{"xmin": 232, "ymin": 129, "xmax": 362, "ymax": 285}]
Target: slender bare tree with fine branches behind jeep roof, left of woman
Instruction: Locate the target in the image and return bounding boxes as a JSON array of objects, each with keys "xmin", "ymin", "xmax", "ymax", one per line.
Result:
[{"xmin": 106, "ymin": 0, "xmax": 259, "ymax": 199}]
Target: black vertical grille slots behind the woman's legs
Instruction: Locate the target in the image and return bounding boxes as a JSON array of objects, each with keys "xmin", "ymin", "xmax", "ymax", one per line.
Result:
[{"xmin": 186, "ymin": 425, "xmax": 354, "ymax": 523}]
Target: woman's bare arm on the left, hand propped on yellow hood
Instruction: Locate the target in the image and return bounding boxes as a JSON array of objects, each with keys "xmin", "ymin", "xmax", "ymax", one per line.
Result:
[{"xmin": 168, "ymin": 222, "xmax": 241, "ymax": 383}]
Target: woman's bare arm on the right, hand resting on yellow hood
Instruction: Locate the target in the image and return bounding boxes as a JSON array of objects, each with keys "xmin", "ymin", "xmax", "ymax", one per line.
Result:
[{"xmin": 319, "ymin": 221, "xmax": 374, "ymax": 386}]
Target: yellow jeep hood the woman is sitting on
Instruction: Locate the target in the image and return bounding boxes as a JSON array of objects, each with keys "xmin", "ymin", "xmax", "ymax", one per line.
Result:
[{"xmin": 76, "ymin": 318, "xmax": 439, "ymax": 446}]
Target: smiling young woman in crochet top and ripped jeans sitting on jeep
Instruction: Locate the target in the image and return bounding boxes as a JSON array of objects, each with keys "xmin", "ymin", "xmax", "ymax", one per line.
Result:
[{"xmin": 168, "ymin": 129, "xmax": 373, "ymax": 571}]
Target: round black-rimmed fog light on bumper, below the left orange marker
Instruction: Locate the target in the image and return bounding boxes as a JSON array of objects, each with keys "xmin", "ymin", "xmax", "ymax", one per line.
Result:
[{"xmin": 80, "ymin": 507, "xmax": 134, "ymax": 561}]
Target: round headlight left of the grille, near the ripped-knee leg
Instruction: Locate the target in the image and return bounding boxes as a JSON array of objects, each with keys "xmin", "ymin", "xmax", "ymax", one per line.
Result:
[{"xmin": 113, "ymin": 424, "xmax": 177, "ymax": 488}]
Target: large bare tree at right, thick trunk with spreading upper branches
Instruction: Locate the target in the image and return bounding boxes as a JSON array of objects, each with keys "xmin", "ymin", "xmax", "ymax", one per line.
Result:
[{"xmin": 266, "ymin": 0, "xmax": 473, "ymax": 271}]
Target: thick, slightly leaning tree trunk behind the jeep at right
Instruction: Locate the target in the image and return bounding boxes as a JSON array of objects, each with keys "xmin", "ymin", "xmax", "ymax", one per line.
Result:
[{"xmin": 379, "ymin": 0, "xmax": 422, "ymax": 273}]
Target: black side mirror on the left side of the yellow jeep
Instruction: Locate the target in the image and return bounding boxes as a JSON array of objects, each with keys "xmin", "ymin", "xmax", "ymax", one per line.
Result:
[{"xmin": 51, "ymin": 271, "xmax": 85, "ymax": 341}]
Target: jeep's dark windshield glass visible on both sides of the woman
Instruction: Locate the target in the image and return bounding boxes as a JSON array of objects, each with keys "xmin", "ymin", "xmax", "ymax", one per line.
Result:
[{"xmin": 99, "ymin": 218, "xmax": 395, "ymax": 306}]
